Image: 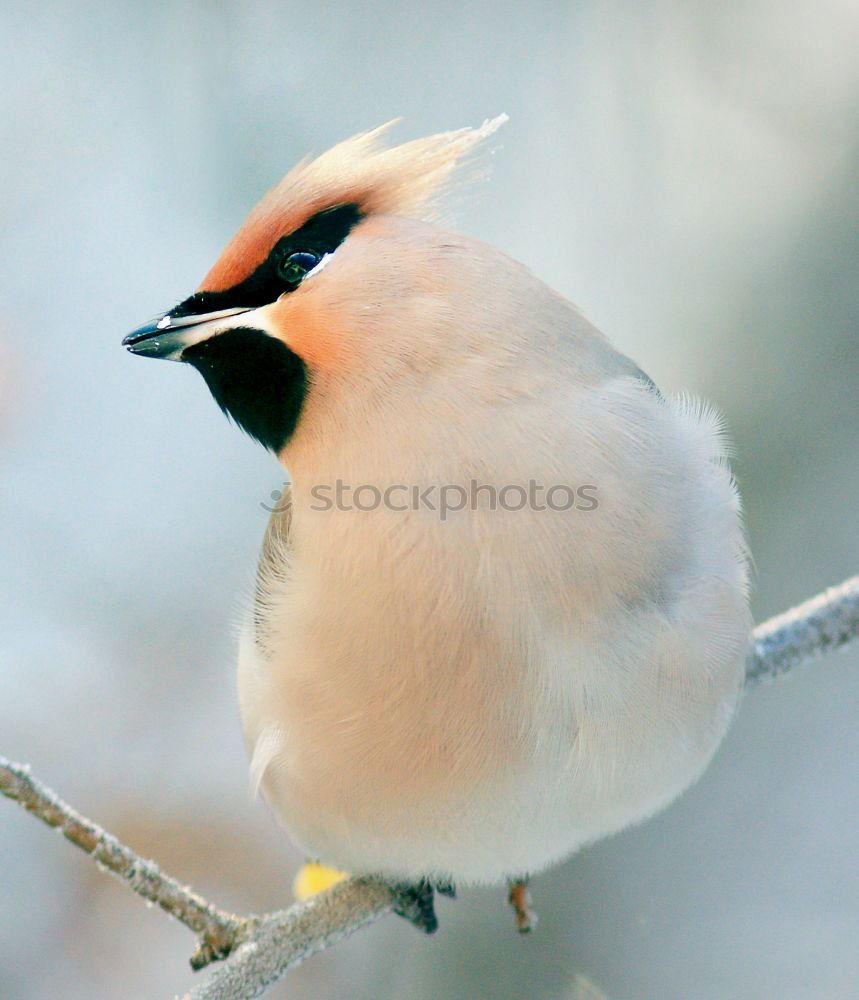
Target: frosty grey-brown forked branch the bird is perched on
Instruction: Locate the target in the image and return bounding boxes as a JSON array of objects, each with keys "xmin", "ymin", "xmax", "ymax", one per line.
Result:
[{"xmin": 0, "ymin": 576, "xmax": 859, "ymax": 1000}]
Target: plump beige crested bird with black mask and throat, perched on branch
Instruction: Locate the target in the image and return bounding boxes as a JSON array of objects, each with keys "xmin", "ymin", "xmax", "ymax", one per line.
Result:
[{"xmin": 123, "ymin": 115, "xmax": 751, "ymax": 932}]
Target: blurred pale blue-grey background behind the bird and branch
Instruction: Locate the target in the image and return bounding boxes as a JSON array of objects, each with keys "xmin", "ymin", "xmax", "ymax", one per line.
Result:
[{"xmin": 0, "ymin": 0, "xmax": 859, "ymax": 1000}]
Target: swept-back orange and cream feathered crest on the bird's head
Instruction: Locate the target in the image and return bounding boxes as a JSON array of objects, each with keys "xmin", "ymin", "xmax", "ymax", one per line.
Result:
[{"xmin": 200, "ymin": 114, "xmax": 507, "ymax": 291}]
